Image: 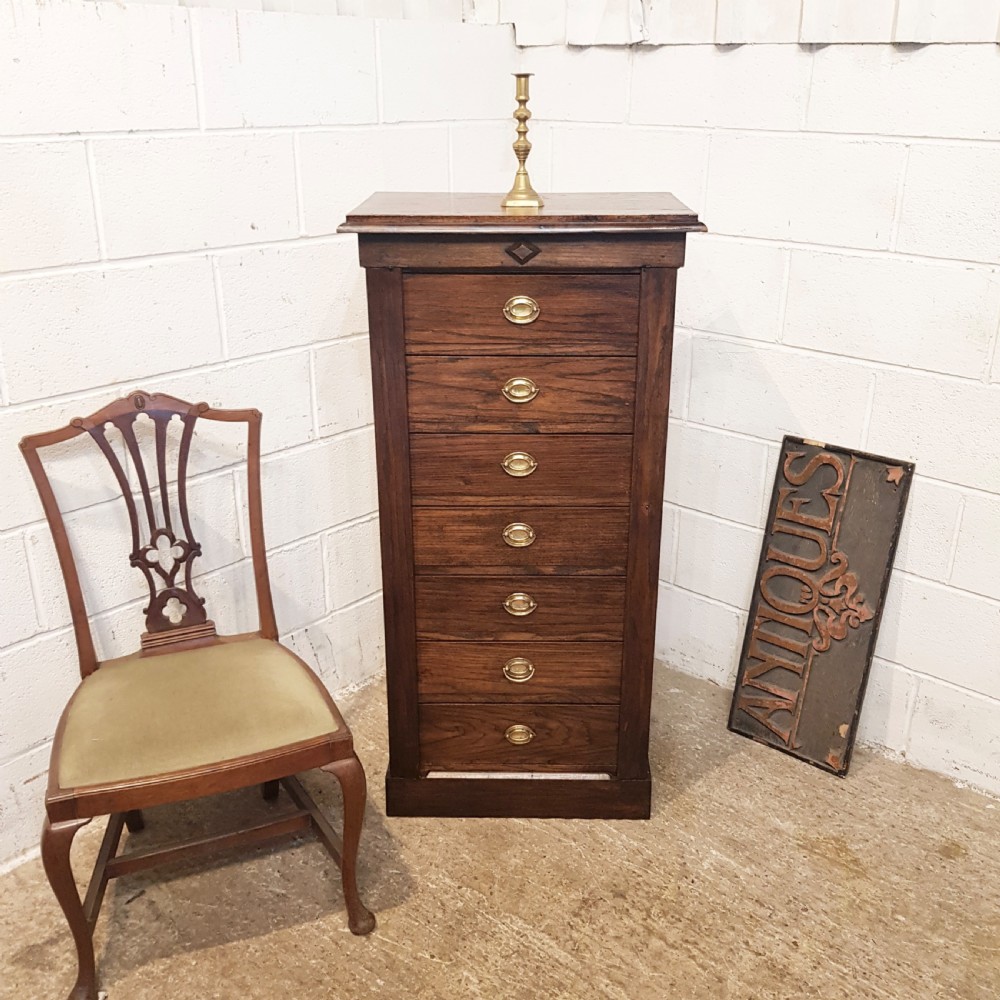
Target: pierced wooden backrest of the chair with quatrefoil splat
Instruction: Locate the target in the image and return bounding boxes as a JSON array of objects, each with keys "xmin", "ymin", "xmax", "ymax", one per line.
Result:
[{"xmin": 21, "ymin": 391, "xmax": 278, "ymax": 677}]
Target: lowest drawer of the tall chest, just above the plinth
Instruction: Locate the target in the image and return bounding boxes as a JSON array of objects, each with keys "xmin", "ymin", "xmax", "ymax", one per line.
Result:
[{"xmin": 420, "ymin": 704, "xmax": 618, "ymax": 772}]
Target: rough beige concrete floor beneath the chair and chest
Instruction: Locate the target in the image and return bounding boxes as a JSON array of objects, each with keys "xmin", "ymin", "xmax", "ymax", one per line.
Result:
[{"xmin": 0, "ymin": 671, "xmax": 1000, "ymax": 1000}]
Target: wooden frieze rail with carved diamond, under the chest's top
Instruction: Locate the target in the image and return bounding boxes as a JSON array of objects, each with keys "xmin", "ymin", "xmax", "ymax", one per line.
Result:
[{"xmin": 359, "ymin": 232, "xmax": 684, "ymax": 274}]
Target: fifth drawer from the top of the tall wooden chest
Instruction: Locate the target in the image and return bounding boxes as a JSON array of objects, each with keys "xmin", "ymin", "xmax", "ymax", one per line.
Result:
[{"xmin": 415, "ymin": 576, "xmax": 625, "ymax": 642}]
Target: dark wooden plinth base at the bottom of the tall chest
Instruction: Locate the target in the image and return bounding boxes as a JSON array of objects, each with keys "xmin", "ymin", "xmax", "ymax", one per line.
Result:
[{"xmin": 385, "ymin": 774, "xmax": 650, "ymax": 819}]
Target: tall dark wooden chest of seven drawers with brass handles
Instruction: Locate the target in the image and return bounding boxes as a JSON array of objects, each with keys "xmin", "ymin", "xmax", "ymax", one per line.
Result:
[{"xmin": 340, "ymin": 194, "xmax": 704, "ymax": 818}]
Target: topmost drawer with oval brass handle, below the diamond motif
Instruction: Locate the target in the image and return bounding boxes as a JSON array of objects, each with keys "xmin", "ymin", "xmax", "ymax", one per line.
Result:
[{"xmin": 403, "ymin": 274, "xmax": 639, "ymax": 355}]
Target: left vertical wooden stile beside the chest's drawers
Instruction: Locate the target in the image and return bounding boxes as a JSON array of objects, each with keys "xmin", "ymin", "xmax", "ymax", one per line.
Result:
[{"xmin": 366, "ymin": 269, "xmax": 419, "ymax": 777}]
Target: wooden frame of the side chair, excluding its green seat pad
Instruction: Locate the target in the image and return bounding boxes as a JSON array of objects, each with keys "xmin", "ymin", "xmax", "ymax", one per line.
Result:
[{"xmin": 21, "ymin": 386, "xmax": 378, "ymax": 1000}]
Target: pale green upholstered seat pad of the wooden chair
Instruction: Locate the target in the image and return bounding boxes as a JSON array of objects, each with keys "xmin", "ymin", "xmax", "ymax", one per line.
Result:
[{"xmin": 53, "ymin": 638, "xmax": 338, "ymax": 788}]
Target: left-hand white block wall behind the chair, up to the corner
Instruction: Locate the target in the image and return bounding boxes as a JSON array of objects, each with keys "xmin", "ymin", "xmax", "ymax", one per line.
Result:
[{"xmin": 0, "ymin": 0, "xmax": 518, "ymax": 864}]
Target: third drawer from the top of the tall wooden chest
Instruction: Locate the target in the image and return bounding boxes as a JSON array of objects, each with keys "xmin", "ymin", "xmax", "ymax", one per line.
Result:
[{"xmin": 410, "ymin": 434, "xmax": 632, "ymax": 506}]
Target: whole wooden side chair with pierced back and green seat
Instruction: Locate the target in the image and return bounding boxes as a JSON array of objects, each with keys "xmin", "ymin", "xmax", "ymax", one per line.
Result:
[{"xmin": 21, "ymin": 392, "xmax": 375, "ymax": 1000}]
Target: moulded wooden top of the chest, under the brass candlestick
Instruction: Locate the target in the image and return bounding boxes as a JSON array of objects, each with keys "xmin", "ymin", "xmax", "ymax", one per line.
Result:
[{"xmin": 337, "ymin": 191, "xmax": 705, "ymax": 234}]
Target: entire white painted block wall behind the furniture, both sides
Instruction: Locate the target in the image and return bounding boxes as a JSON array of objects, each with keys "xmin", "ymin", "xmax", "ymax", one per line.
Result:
[{"xmin": 0, "ymin": 0, "xmax": 1000, "ymax": 864}]
